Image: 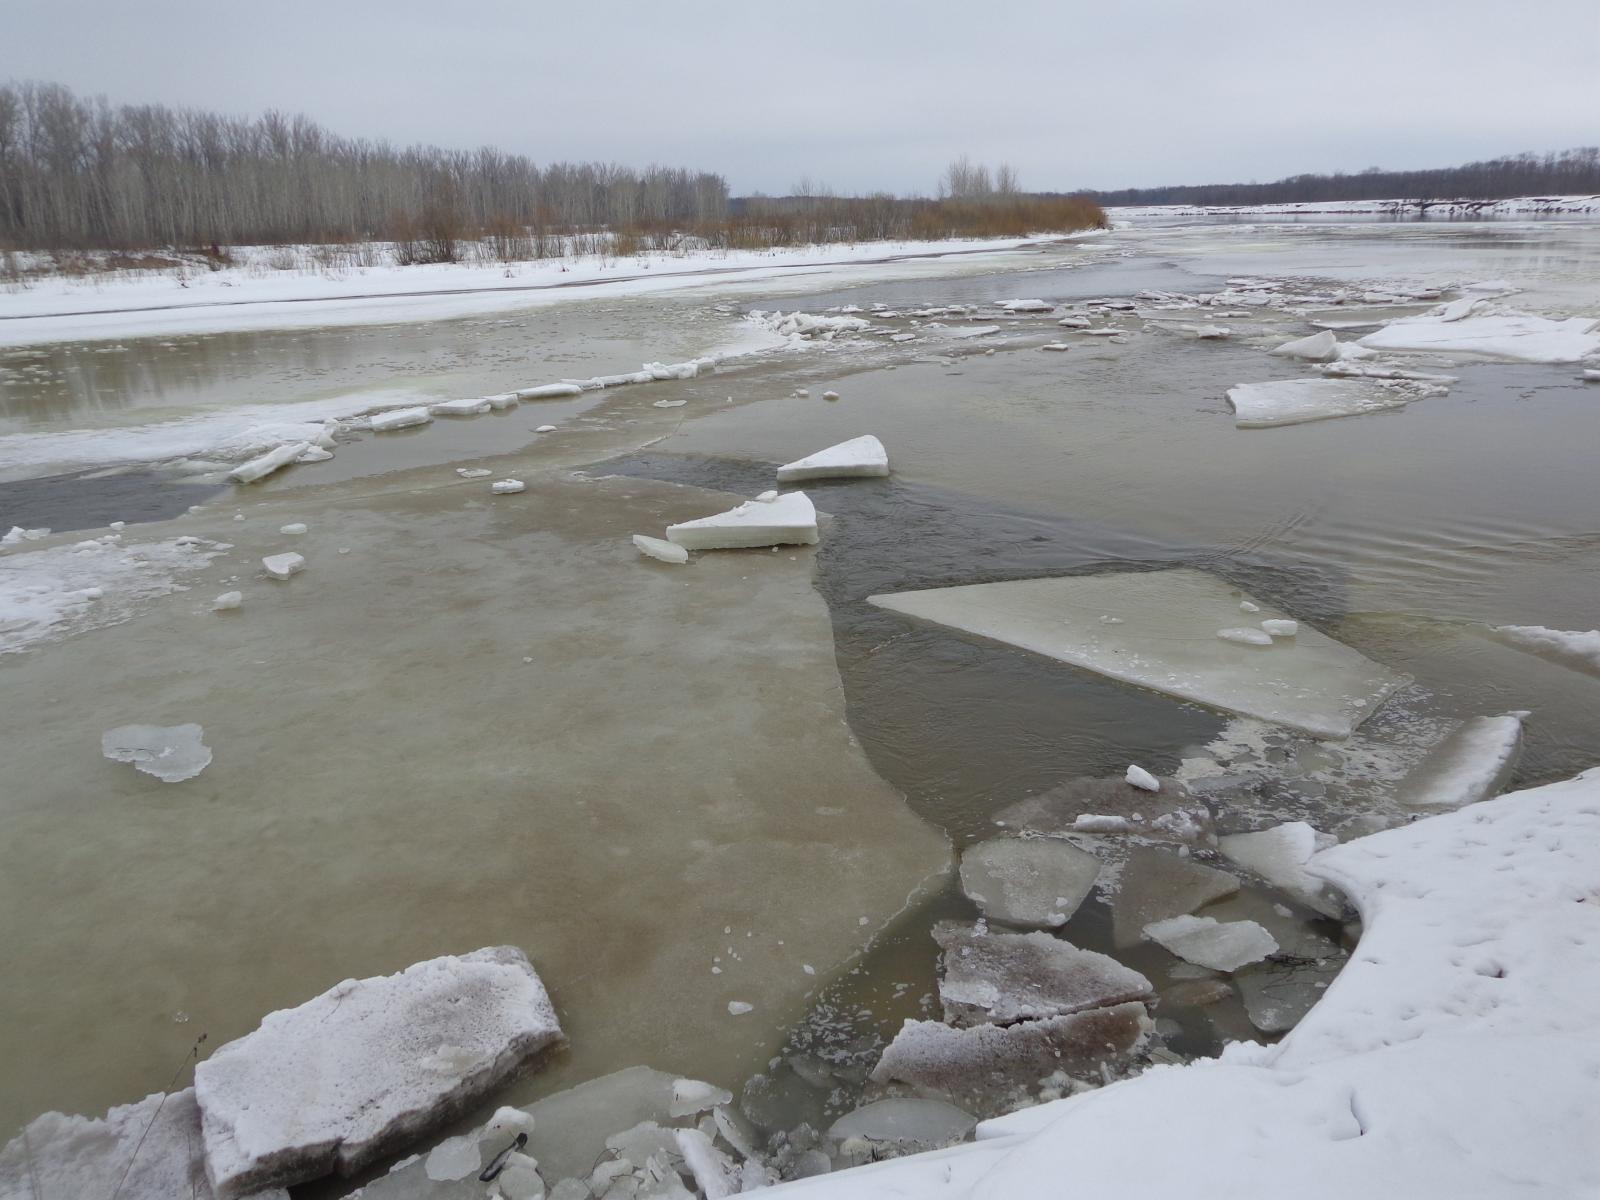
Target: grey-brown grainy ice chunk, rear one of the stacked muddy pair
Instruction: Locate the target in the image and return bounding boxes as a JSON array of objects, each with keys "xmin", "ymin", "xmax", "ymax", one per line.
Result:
[{"xmin": 933, "ymin": 922, "xmax": 1150, "ymax": 1026}]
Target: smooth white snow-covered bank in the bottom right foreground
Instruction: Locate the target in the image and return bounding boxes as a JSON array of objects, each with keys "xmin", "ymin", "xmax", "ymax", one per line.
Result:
[{"xmin": 776, "ymin": 768, "xmax": 1600, "ymax": 1200}]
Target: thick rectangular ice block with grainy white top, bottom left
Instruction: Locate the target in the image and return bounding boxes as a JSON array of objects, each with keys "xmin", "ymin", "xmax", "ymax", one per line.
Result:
[{"xmin": 195, "ymin": 946, "xmax": 562, "ymax": 1200}]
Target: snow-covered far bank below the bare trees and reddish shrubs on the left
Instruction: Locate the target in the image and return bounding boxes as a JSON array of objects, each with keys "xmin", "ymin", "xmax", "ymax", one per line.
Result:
[{"xmin": 0, "ymin": 230, "xmax": 1068, "ymax": 346}]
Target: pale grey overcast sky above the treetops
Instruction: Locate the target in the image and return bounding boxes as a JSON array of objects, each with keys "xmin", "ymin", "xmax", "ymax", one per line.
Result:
[{"xmin": 12, "ymin": 0, "xmax": 1600, "ymax": 194}]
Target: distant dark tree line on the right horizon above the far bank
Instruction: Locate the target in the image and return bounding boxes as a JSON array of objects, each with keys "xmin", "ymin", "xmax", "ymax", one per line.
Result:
[{"xmin": 1083, "ymin": 146, "xmax": 1600, "ymax": 205}]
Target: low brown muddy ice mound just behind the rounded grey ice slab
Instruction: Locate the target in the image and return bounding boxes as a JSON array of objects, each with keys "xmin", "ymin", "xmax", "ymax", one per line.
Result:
[{"xmin": 995, "ymin": 776, "xmax": 1213, "ymax": 843}]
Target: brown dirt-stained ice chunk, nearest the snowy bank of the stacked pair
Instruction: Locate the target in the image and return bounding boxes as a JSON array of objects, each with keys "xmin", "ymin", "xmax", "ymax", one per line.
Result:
[{"xmin": 872, "ymin": 1000, "xmax": 1150, "ymax": 1114}]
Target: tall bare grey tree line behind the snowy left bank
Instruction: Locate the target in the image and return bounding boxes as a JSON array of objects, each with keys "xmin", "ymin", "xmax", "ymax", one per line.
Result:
[{"xmin": 0, "ymin": 83, "xmax": 728, "ymax": 256}]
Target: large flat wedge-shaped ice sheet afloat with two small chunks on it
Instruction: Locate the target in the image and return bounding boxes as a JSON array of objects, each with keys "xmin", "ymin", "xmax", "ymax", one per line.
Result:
[{"xmin": 869, "ymin": 568, "xmax": 1402, "ymax": 738}]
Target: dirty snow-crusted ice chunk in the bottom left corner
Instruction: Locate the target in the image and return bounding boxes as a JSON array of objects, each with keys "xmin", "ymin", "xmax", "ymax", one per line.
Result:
[{"xmin": 0, "ymin": 1088, "xmax": 288, "ymax": 1200}]
